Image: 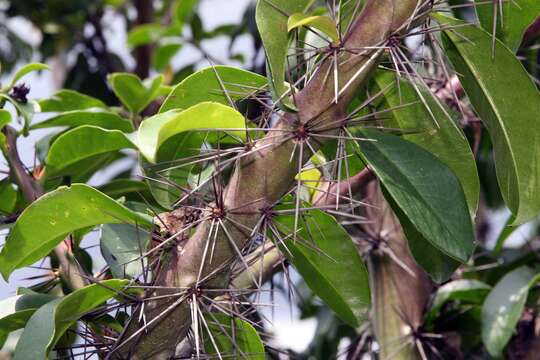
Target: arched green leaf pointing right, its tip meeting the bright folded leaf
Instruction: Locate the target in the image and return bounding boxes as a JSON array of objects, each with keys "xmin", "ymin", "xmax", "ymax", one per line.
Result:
[{"xmin": 45, "ymin": 125, "xmax": 136, "ymax": 177}]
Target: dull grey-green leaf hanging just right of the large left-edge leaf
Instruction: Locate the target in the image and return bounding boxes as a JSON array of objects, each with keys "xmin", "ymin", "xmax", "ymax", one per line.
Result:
[{"xmin": 100, "ymin": 224, "xmax": 150, "ymax": 279}]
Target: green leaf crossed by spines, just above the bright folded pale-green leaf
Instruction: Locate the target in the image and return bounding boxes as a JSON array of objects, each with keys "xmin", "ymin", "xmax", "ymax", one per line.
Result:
[{"xmin": 159, "ymin": 65, "xmax": 267, "ymax": 113}]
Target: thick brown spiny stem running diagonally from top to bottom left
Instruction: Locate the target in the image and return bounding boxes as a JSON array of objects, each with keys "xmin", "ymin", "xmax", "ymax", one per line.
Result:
[{"xmin": 113, "ymin": 0, "xmax": 428, "ymax": 359}]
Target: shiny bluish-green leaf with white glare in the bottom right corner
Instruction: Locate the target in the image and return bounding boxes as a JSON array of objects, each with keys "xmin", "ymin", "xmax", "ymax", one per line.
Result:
[{"xmin": 482, "ymin": 266, "xmax": 540, "ymax": 357}]
